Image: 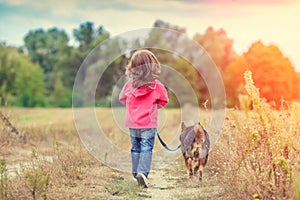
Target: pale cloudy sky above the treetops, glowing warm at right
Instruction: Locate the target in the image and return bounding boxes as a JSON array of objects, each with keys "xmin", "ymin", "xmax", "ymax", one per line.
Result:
[{"xmin": 0, "ymin": 0, "xmax": 300, "ymax": 72}]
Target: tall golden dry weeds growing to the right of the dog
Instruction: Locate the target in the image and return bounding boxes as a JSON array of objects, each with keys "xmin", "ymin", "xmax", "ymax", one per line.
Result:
[{"xmin": 214, "ymin": 71, "xmax": 300, "ymax": 199}]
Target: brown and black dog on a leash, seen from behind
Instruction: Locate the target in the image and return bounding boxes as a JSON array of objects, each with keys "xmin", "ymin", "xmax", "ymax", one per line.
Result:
[{"xmin": 180, "ymin": 122, "xmax": 210, "ymax": 181}]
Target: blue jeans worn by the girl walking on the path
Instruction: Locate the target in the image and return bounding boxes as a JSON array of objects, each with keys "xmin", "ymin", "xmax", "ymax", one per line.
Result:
[{"xmin": 129, "ymin": 128, "xmax": 157, "ymax": 178}]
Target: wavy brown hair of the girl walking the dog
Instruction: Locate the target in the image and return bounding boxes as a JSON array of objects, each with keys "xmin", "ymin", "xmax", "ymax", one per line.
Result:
[{"xmin": 126, "ymin": 50, "xmax": 161, "ymax": 88}]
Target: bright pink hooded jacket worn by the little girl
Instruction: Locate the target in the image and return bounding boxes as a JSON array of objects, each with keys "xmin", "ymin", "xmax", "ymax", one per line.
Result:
[{"xmin": 119, "ymin": 80, "xmax": 169, "ymax": 128}]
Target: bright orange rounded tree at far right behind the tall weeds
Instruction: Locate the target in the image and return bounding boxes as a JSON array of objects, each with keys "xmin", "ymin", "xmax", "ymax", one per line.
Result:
[{"xmin": 224, "ymin": 41, "xmax": 299, "ymax": 108}]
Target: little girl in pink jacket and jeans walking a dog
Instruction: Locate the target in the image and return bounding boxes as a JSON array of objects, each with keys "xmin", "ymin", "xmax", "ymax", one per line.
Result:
[{"xmin": 119, "ymin": 50, "xmax": 169, "ymax": 188}]
